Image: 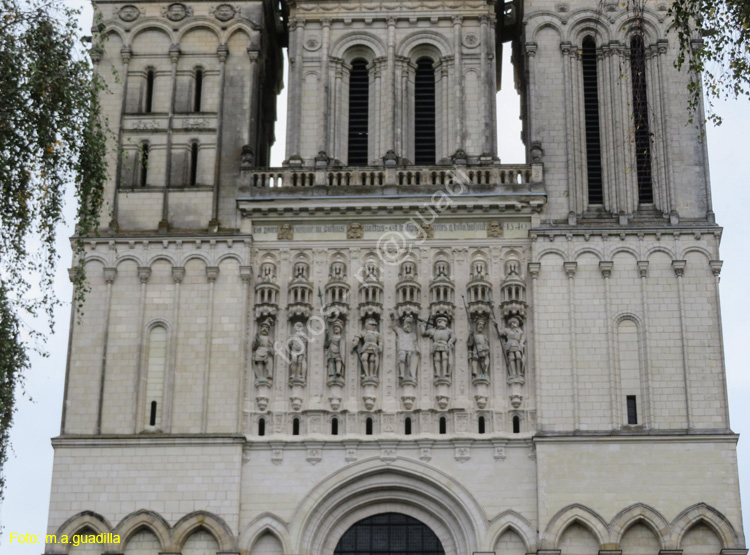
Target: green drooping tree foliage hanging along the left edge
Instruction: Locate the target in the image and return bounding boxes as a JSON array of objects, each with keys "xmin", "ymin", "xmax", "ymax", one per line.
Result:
[{"xmin": 0, "ymin": 0, "xmax": 107, "ymax": 499}]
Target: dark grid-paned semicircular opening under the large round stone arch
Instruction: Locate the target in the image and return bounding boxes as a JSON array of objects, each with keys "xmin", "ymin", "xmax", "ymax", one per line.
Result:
[{"xmin": 333, "ymin": 513, "xmax": 445, "ymax": 555}]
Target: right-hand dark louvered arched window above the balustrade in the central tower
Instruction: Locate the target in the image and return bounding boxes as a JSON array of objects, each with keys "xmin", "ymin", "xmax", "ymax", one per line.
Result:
[{"xmin": 414, "ymin": 58, "xmax": 436, "ymax": 165}]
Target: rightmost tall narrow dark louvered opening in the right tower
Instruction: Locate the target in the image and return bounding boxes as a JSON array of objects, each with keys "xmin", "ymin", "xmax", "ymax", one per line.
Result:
[{"xmin": 630, "ymin": 35, "xmax": 654, "ymax": 204}]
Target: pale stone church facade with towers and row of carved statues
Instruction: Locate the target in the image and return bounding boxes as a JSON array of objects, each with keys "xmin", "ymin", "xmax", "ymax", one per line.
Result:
[{"xmin": 45, "ymin": 0, "xmax": 747, "ymax": 555}]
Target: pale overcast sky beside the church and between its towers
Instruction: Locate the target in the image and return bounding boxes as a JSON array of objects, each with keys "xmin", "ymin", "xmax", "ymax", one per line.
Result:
[{"xmin": 0, "ymin": 3, "xmax": 750, "ymax": 555}]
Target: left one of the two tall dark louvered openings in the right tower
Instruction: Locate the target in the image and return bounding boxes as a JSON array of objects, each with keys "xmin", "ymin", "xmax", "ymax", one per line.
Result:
[{"xmin": 581, "ymin": 37, "xmax": 604, "ymax": 204}]
